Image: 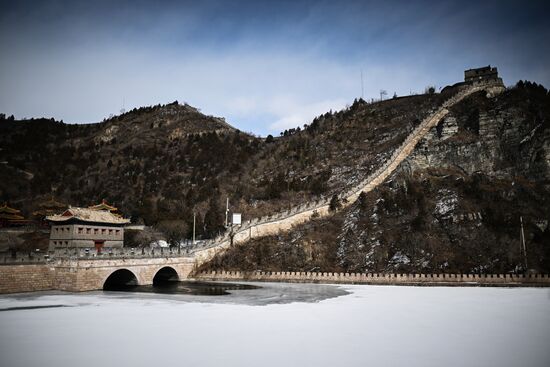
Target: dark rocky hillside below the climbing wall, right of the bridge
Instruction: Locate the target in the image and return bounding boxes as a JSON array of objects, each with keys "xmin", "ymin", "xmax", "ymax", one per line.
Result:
[{"xmin": 208, "ymin": 84, "xmax": 550, "ymax": 272}]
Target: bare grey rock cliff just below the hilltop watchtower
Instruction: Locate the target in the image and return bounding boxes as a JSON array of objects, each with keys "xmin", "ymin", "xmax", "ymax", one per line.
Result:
[{"xmin": 407, "ymin": 91, "xmax": 550, "ymax": 181}]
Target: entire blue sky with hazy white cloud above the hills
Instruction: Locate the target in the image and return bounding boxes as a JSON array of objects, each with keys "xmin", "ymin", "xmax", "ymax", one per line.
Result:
[{"xmin": 0, "ymin": 0, "xmax": 550, "ymax": 135}]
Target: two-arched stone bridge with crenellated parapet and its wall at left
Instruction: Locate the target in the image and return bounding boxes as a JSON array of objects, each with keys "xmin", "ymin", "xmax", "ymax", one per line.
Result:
[{"xmin": 0, "ymin": 249, "xmax": 196, "ymax": 294}]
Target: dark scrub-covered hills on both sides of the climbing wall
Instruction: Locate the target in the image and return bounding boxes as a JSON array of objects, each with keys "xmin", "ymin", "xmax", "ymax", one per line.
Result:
[{"xmin": 0, "ymin": 82, "xmax": 550, "ymax": 271}]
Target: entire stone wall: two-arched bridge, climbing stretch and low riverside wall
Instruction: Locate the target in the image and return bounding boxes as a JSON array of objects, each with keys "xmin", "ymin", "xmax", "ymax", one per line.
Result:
[{"xmin": 4, "ymin": 80, "xmax": 550, "ymax": 293}]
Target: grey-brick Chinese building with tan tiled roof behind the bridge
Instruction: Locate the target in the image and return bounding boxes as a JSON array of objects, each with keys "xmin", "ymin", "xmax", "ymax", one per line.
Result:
[{"xmin": 46, "ymin": 208, "xmax": 130, "ymax": 251}]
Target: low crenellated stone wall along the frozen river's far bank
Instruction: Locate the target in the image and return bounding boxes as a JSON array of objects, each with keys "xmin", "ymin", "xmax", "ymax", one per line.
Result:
[{"xmin": 194, "ymin": 271, "xmax": 550, "ymax": 287}]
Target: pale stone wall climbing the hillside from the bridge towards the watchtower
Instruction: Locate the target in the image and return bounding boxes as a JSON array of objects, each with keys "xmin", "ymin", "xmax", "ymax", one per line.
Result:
[{"xmin": 193, "ymin": 82, "xmax": 504, "ymax": 265}]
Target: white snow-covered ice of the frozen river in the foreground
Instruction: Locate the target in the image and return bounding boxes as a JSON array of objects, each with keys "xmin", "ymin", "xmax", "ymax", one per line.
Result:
[{"xmin": 0, "ymin": 283, "xmax": 550, "ymax": 367}]
